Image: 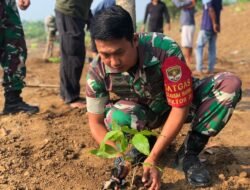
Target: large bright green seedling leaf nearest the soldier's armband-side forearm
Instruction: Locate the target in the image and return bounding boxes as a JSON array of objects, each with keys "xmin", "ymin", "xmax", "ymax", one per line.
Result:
[{"xmin": 132, "ymin": 133, "xmax": 149, "ymax": 155}]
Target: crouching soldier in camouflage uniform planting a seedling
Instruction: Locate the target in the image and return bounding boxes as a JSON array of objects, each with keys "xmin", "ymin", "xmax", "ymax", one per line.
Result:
[{"xmin": 86, "ymin": 6, "xmax": 241, "ymax": 190}]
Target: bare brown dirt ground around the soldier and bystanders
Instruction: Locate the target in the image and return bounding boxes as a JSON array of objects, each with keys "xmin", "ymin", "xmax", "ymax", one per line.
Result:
[{"xmin": 0, "ymin": 4, "xmax": 250, "ymax": 190}]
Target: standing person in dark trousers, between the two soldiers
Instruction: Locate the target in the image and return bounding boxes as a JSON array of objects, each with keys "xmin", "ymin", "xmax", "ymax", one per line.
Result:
[{"xmin": 55, "ymin": 0, "xmax": 92, "ymax": 108}]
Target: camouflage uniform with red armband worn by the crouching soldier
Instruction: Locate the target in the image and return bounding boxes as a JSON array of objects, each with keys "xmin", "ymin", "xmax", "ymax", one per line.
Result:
[{"xmin": 86, "ymin": 33, "xmax": 241, "ymax": 136}]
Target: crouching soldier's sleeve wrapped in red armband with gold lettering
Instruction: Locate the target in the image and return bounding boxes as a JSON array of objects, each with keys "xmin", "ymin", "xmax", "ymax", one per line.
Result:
[{"xmin": 161, "ymin": 39, "xmax": 193, "ymax": 107}]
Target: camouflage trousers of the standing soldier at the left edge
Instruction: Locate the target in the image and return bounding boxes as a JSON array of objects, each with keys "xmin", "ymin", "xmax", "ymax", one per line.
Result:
[{"xmin": 0, "ymin": 0, "xmax": 27, "ymax": 91}]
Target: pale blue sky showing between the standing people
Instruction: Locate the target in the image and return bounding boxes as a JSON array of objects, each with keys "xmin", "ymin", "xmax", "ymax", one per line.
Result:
[{"xmin": 19, "ymin": 0, "xmax": 150, "ymax": 22}]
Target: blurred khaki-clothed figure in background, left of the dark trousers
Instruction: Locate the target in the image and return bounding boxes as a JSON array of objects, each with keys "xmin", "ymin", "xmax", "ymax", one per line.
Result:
[{"xmin": 43, "ymin": 15, "xmax": 57, "ymax": 61}]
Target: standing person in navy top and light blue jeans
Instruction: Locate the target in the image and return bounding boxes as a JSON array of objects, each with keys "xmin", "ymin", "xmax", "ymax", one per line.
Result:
[{"xmin": 194, "ymin": 0, "xmax": 222, "ymax": 75}]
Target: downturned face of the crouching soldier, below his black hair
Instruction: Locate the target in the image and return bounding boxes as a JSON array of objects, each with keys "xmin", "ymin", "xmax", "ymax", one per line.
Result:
[{"xmin": 95, "ymin": 35, "xmax": 138, "ymax": 72}]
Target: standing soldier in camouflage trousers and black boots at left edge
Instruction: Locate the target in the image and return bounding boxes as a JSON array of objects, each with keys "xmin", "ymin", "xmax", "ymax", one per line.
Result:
[{"xmin": 0, "ymin": 0, "xmax": 39, "ymax": 114}]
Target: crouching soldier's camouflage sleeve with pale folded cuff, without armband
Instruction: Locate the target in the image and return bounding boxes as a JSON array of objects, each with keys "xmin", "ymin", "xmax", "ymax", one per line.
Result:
[{"xmin": 86, "ymin": 60, "xmax": 109, "ymax": 114}]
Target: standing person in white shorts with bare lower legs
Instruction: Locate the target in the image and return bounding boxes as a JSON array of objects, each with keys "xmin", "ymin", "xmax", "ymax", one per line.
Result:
[{"xmin": 172, "ymin": 0, "xmax": 195, "ymax": 65}]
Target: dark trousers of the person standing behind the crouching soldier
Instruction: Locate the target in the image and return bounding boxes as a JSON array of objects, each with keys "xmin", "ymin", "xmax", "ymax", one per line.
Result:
[{"xmin": 55, "ymin": 10, "xmax": 86, "ymax": 103}]
